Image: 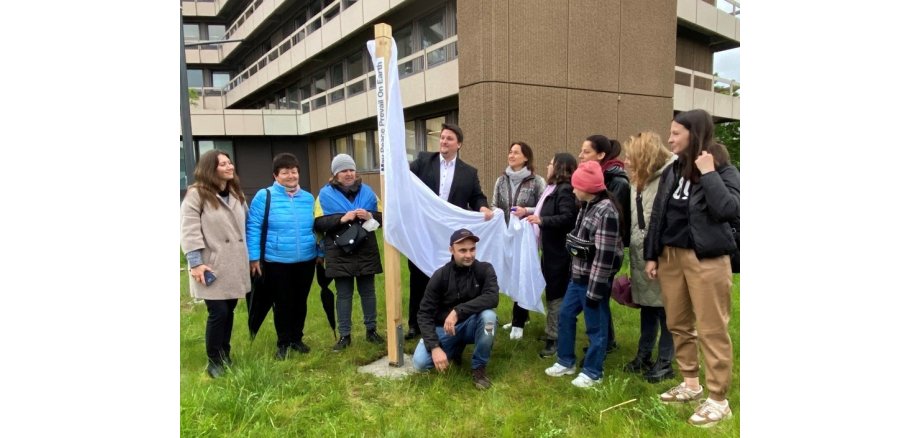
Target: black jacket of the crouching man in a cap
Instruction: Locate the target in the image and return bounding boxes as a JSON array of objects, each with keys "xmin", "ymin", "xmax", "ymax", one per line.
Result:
[{"xmin": 418, "ymin": 258, "xmax": 498, "ymax": 351}]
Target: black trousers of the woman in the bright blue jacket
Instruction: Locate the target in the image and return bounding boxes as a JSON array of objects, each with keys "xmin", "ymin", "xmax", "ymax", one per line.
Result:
[{"xmin": 262, "ymin": 259, "xmax": 316, "ymax": 347}]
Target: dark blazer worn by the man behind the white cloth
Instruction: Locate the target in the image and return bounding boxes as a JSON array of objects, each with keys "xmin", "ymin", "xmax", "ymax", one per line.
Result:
[{"xmin": 409, "ymin": 152, "xmax": 489, "ymax": 211}]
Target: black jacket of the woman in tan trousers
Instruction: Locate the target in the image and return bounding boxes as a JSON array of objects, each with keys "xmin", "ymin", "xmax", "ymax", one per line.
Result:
[{"xmin": 644, "ymin": 161, "xmax": 741, "ymax": 261}]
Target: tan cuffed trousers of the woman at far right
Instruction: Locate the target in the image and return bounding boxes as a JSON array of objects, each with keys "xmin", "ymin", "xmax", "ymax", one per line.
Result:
[{"xmin": 658, "ymin": 246, "xmax": 732, "ymax": 400}]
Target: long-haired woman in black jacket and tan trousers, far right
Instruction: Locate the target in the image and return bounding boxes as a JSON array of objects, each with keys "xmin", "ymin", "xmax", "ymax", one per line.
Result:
[{"xmin": 645, "ymin": 109, "xmax": 741, "ymax": 427}]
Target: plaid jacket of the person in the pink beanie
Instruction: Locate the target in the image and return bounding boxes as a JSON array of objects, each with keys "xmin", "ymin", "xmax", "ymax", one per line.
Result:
[{"xmin": 572, "ymin": 196, "xmax": 623, "ymax": 301}]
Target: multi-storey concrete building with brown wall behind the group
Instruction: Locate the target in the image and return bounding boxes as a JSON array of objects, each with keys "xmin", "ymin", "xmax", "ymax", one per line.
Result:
[{"xmin": 180, "ymin": 0, "xmax": 740, "ymax": 197}]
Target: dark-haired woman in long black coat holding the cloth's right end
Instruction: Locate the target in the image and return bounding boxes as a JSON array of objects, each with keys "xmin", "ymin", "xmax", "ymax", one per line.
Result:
[{"xmin": 524, "ymin": 152, "xmax": 578, "ymax": 358}]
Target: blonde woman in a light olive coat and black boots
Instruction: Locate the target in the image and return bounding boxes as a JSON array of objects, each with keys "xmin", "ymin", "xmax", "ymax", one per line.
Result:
[{"xmin": 624, "ymin": 131, "xmax": 677, "ymax": 383}]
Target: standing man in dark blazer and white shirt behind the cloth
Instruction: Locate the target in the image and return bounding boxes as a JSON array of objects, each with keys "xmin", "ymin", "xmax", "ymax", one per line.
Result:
[{"xmin": 406, "ymin": 123, "xmax": 492, "ymax": 340}]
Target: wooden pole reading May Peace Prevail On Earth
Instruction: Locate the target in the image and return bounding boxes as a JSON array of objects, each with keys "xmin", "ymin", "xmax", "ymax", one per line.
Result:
[{"xmin": 374, "ymin": 23, "xmax": 404, "ymax": 367}]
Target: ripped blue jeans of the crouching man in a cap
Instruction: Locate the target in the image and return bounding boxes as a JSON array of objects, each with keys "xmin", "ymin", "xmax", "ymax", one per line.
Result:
[{"xmin": 412, "ymin": 309, "xmax": 498, "ymax": 370}]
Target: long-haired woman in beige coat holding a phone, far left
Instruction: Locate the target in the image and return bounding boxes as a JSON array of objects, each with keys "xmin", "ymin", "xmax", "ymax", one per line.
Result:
[{"xmin": 181, "ymin": 150, "xmax": 251, "ymax": 378}]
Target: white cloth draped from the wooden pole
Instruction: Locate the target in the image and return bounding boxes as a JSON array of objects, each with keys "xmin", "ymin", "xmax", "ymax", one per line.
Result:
[{"xmin": 367, "ymin": 40, "xmax": 546, "ymax": 314}]
